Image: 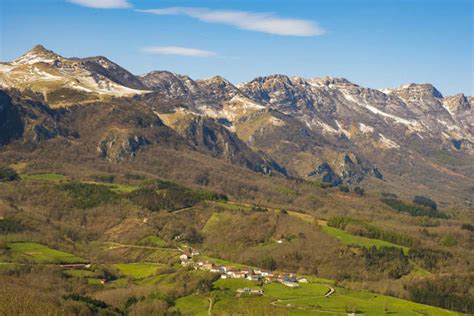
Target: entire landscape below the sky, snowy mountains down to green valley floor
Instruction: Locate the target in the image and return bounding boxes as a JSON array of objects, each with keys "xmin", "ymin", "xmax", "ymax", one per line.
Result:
[{"xmin": 0, "ymin": 45, "xmax": 474, "ymax": 315}]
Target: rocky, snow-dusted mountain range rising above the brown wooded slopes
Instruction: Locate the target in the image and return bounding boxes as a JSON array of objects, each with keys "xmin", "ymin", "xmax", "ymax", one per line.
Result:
[{"xmin": 0, "ymin": 45, "xmax": 474, "ymax": 207}]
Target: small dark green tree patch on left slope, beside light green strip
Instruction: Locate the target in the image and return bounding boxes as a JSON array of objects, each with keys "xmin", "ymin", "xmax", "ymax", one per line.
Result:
[{"xmin": 61, "ymin": 182, "xmax": 118, "ymax": 209}]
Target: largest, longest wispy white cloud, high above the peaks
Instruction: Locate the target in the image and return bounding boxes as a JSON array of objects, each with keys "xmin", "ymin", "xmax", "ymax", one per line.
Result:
[{"xmin": 137, "ymin": 7, "xmax": 325, "ymax": 36}]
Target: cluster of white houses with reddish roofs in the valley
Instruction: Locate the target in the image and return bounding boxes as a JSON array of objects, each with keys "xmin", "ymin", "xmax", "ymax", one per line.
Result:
[{"xmin": 180, "ymin": 250, "xmax": 308, "ymax": 294}]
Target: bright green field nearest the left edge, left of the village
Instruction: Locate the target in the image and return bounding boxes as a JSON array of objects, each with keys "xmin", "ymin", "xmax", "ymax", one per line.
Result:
[{"xmin": 8, "ymin": 242, "xmax": 87, "ymax": 264}]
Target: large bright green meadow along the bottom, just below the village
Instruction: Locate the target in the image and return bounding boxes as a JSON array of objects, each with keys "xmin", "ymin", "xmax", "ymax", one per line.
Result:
[{"xmin": 176, "ymin": 279, "xmax": 457, "ymax": 316}]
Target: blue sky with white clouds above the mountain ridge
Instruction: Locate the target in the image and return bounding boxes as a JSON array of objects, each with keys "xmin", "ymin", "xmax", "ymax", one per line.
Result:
[{"xmin": 0, "ymin": 0, "xmax": 474, "ymax": 95}]
